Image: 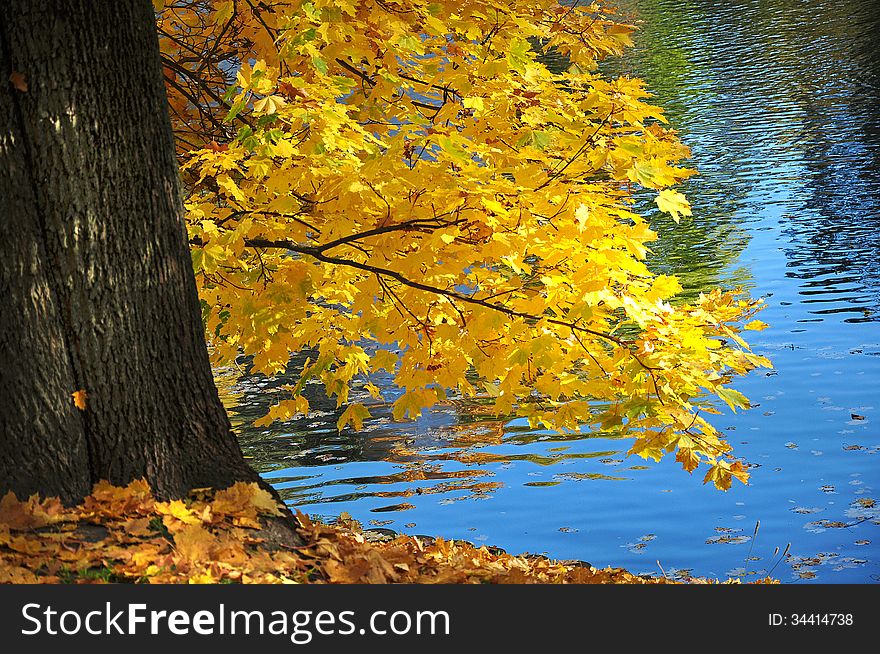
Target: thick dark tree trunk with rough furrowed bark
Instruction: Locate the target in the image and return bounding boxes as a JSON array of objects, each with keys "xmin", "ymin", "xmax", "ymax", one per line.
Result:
[{"xmin": 0, "ymin": 0, "xmax": 258, "ymax": 503}]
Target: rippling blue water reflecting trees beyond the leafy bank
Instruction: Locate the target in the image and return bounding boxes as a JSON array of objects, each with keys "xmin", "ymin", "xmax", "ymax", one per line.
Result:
[{"xmin": 223, "ymin": 0, "xmax": 880, "ymax": 583}]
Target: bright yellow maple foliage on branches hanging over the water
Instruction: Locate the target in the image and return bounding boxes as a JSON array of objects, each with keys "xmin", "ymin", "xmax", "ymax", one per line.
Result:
[{"xmin": 158, "ymin": 0, "xmax": 769, "ymax": 489}]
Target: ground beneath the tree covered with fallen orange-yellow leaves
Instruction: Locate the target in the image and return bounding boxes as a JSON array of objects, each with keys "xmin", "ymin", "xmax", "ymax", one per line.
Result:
[{"xmin": 0, "ymin": 481, "xmax": 768, "ymax": 584}]
